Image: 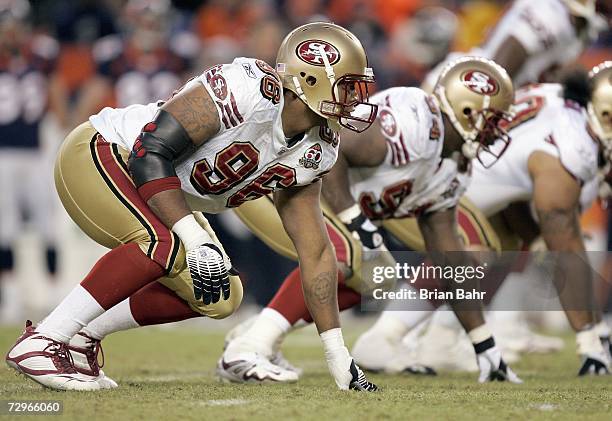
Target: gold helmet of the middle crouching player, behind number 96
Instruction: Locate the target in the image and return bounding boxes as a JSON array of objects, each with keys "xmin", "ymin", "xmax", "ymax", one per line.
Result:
[{"xmin": 434, "ymin": 56, "xmax": 514, "ymax": 167}]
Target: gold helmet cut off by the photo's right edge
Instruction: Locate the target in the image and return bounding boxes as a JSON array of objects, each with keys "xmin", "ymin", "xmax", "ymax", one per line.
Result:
[{"xmin": 587, "ymin": 61, "xmax": 612, "ymax": 150}]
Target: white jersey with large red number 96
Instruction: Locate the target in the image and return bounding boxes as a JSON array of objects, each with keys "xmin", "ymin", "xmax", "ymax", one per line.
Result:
[{"xmin": 89, "ymin": 58, "xmax": 338, "ymax": 213}]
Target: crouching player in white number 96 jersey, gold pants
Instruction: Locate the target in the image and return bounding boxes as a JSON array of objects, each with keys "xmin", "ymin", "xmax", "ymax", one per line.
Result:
[{"xmin": 6, "ymin": 23, "xmax": 377, "ymax": 391}]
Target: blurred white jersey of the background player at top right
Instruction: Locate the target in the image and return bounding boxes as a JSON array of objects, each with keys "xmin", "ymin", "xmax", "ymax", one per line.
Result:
[{"xmin": 425, "ymin": 0, "xmax": 586, "ymax": 89}]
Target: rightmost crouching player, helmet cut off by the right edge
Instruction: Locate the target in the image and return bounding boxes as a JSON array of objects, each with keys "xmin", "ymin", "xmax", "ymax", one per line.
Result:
[{"xmin": 353, "ymin": 62, "xmax": 612, "ymax": 375}]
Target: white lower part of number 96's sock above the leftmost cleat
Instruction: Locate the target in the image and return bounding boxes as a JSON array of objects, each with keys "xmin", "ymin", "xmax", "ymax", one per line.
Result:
[{"xmin": 36, "ymin": 285, "xmax": 104, "ymax": 343}]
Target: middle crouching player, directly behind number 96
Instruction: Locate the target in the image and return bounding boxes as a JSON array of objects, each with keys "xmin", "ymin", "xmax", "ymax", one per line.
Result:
[{"xmin": 217, "ymin": 57, "xmax": 520, "ymax": 383}]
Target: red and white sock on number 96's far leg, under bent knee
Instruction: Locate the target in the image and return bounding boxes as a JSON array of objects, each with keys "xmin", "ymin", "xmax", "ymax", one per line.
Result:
[{"xmin": 83, "ymin": 282, "xmax": 201, "ymax": 340}]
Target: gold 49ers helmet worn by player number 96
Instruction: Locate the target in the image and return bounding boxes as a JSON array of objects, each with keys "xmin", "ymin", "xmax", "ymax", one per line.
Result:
[{"xmin": 276, "ymin": 22, "xmax": 377, "ymax": 132}]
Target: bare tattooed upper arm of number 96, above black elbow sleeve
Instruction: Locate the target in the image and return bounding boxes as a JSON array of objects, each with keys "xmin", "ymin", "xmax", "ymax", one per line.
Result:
[{"xmin": 162, "ymin": 85, "xmax": 220, "ymax": 145}]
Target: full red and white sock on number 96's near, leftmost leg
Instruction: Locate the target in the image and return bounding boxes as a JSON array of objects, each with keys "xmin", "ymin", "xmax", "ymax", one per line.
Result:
[{"xmin": 37, "ymin": 243, "xmax": 164, "ymax": 343}]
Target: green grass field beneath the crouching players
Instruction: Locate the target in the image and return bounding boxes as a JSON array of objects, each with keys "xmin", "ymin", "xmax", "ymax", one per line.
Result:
[{"xmin": 0, "ymin": 325, "xmax": 612, "ymax": 421}]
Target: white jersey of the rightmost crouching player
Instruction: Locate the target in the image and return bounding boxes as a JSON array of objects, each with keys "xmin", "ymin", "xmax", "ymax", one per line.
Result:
[{"xmin": 466, "ymin": 84, "xmax": 598, "ymax": 216}]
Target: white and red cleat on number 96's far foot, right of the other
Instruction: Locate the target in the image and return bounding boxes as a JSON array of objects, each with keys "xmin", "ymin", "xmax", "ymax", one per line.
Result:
[{"xmin": 68, "ymin": 332, "xmax": 119, "ymax": 389}]
